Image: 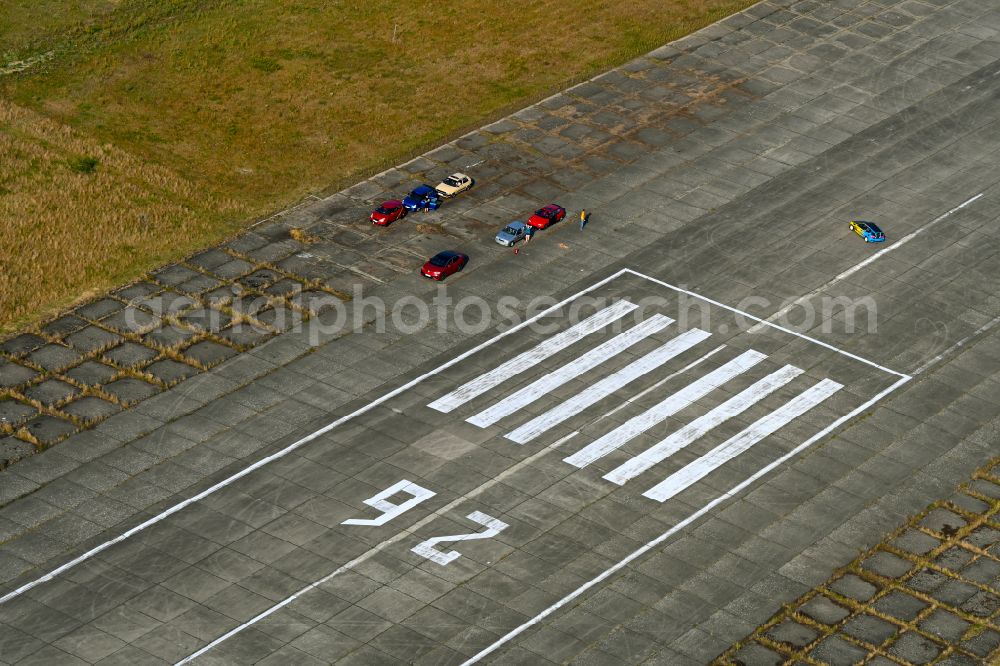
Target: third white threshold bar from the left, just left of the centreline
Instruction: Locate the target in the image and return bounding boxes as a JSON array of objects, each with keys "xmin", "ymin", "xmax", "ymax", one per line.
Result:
[{"xmin": 506, "ymin": 328, "xmax": 711, "ymax": 444}]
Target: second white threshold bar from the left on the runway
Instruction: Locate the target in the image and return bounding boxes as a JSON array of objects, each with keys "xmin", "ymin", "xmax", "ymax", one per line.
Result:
[{"xmin": 466, "ymin": 314, "xmax": 674, "ymax": 428}]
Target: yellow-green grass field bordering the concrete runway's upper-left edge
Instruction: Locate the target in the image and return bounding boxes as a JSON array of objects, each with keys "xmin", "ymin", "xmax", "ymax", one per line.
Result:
[{"xmin": 0, "ymin": 0, "xmax": 753, "ymax": 332}]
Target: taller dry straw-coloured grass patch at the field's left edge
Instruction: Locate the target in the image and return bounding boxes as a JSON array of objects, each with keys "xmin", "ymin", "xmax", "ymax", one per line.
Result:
[{"xmin": 0, "ymin": 99, "xmax": 236, "ymax": 329}]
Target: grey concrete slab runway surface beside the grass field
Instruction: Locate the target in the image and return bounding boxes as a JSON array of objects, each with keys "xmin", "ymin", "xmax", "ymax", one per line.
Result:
[{"xmin": 0, "ymin": 0, "xmax": 1000, "ymax": 665}]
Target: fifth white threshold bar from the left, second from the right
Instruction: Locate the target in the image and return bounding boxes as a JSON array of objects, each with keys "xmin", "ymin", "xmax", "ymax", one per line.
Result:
[{"xmin": 604, "ymin": 365, "xmax": 803, "ymax": 486}]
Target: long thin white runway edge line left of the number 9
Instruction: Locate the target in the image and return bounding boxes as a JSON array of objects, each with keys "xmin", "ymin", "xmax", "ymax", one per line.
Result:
[{"xmin": 0, "ymin": 268, "xmax": 628, "ymax": 605}]
